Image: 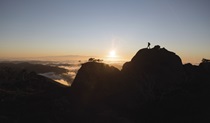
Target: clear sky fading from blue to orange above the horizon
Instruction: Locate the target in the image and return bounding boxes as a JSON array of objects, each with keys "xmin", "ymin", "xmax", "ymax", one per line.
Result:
[{"xmin": 0, "ymin": 0, "xmax": 210, "ymax": 63}]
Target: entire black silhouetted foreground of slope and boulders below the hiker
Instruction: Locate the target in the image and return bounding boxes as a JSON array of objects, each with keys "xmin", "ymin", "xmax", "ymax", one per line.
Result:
[{"xmin": 0, "ymin": 46, "xmax": 210, "ymax": 123}]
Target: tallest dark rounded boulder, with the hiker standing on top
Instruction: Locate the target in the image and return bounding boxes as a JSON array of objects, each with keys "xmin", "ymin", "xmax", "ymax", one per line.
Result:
[{"xmin": 122, "ymin": 46, "xmax": 185, "ymax": 98}]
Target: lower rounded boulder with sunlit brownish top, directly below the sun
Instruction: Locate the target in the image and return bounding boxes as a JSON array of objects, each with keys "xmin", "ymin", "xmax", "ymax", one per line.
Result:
[{"xmin": 71, "ymin": 62, "xmax": 120, "ymax": 105}]
